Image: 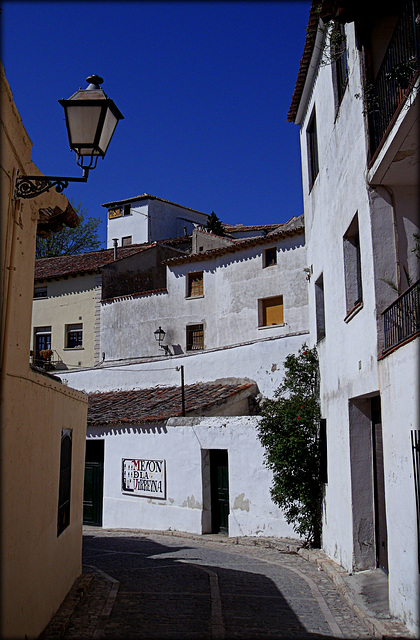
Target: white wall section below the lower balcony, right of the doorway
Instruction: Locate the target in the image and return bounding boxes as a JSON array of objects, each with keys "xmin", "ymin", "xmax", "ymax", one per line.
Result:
[{"xmin": 379, "ymin": 339, "xmax": 420, "ymax": 637}]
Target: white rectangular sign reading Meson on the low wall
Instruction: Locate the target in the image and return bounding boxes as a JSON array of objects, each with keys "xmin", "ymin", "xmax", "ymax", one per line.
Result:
[{"xmin": 122, "ymin": 458, "xmax": 166, "ymax": 498}]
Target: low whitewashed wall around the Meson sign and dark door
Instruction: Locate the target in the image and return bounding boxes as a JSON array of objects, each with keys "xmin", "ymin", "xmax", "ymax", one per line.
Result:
[{"xmin": 88, "ymin": 416, "xmax": 297, "ymax": 537}]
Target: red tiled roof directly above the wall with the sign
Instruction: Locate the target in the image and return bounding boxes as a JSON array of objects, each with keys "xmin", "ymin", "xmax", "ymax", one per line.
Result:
[{"xmin": 87, "ymin": 382, "xmax": 254, "ymax": 427}]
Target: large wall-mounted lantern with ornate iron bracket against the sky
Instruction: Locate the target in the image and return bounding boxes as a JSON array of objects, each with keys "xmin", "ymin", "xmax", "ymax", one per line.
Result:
[{"xmin": 15, "ymin": 75, "xmax": 124, "ymax": 198}]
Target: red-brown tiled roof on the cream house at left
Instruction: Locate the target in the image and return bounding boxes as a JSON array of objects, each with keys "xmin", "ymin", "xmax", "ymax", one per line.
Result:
[{"xmin": 35, "ymin": 242, "xmax": 155, "ymax": 280}]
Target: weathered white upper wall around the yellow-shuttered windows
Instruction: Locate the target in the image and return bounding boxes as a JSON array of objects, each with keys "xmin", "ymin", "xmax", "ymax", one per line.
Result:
[{"xmin": 100, "ymin": 235, "xmax": 308, "ymax": 362}]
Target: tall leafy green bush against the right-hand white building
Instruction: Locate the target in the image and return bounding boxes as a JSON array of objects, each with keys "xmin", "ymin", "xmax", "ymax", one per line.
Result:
[{"xmin": 258, "ymin": 345, "xmax": 323, "ymax": 547}]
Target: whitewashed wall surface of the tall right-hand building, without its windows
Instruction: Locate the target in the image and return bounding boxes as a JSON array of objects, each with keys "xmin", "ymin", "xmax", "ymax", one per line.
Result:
[{"xmin": 300, "ymin": 18, "xmax": 418, "ymax": 633}]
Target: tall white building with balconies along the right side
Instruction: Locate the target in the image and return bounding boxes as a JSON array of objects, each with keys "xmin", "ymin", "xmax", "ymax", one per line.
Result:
[{"xmin": 289, "ymin": 1, "xmax": 420, "ymax": 633}]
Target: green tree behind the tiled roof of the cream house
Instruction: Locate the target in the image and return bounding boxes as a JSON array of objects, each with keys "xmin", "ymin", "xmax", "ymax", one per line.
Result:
[{"xmin": 35, "ymin": 201, "xmax": 102, "ymax": 260}]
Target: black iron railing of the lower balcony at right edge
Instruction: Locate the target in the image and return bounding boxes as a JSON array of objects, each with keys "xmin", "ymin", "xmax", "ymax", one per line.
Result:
[{"xmin": 382, "ymin": 280, "xmax": 420, "ymax": 353}]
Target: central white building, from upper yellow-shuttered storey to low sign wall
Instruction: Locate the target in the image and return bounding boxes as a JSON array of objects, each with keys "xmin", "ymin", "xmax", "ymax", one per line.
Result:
[{"xmin": 55, "ymin": 211, "xmax": 308, "ymax": 537}]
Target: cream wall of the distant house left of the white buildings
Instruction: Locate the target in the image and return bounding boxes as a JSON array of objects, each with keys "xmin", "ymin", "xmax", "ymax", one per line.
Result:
[{"xmin": 31, "ymin": 274, "xmax": 101, "ymax": 369}]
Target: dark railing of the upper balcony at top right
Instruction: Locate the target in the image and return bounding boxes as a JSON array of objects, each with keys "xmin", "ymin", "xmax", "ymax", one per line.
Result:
[{"xmin": 365, "ymin": 0, "xmax": 420, "ymax": 154}]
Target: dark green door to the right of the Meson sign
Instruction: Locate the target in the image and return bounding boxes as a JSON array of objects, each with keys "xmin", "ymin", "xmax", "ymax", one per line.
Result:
[{"xmin": 210, "ymin": 449, "xmax": 229, "ymax": 533}]
